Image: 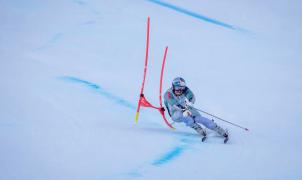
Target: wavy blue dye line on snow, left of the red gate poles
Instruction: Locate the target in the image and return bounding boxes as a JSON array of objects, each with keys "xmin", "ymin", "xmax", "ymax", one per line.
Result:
[{"xmin": 59, "ymin": 76, "xmax": 136, "ymax": 110}]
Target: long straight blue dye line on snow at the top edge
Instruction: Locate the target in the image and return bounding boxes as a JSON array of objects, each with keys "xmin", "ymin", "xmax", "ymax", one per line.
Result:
[{"xmin": 148, "ymin": 0, "xmax": 245, "ymax": 31}]
